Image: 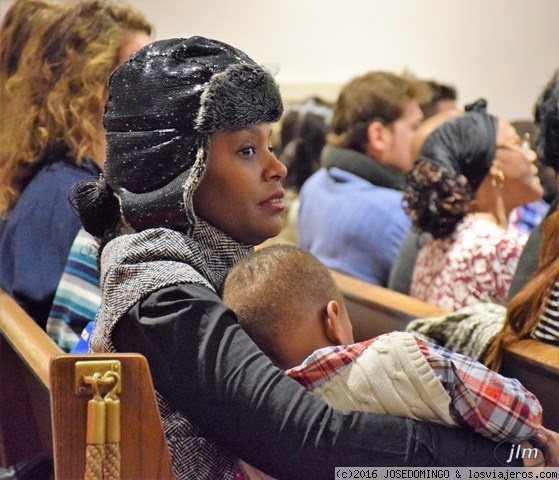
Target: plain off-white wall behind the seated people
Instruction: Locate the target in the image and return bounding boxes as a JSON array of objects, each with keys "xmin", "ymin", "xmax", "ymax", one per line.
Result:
[{"xmin": 0, "ymin": 0, "xmax": 559, "ymax": 120}]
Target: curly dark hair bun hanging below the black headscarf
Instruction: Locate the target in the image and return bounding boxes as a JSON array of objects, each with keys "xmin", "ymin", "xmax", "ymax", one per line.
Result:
[{"xmin": 403, "ymin": 159, "xmax": 473, "ymax": 238}]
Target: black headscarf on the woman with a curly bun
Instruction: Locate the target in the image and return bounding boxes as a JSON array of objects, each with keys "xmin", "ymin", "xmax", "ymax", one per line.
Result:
[{"xmin": 416, "ymin": 100, "xmax": 497, "ymax": 192}]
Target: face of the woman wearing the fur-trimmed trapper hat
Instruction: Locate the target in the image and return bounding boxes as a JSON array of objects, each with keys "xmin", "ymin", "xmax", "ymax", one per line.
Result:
[{"xmin": 194, "ymin": 123, "xmax": 287, "ymax": 245}]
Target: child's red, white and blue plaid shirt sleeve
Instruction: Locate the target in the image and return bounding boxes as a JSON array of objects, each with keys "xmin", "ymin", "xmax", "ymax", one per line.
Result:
[{"xmin": 416, "ymin": 339, "xmax": 542, "ymax": 441}]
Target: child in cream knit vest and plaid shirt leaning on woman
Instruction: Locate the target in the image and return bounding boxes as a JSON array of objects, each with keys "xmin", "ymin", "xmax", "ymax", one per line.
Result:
[{"xmin": 223, "ymin": 245, "xmax": 542, "ymax": 441}]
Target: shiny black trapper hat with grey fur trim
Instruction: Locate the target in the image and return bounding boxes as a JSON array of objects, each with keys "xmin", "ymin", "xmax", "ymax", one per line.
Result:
[{"xmin": 104, "ymin": 37, "xmax": 283, "ymax": 231}]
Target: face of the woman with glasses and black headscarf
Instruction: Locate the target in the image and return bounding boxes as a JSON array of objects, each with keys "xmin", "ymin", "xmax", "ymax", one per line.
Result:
[{"xmin": 492, "ymin": 119, "xmax": 543, "ymax": 208}]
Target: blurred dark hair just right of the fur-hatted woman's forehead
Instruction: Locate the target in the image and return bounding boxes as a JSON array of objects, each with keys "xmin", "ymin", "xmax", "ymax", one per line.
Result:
[{"xmin": 278, "ymin": 97, "xmax": 332, "ymax": 191}]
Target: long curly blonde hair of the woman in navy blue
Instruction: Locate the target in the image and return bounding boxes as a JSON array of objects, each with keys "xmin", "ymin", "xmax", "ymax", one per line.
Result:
[{"xmin": 0, "ymin": 0, "xmax": 153, "ymax": 214}]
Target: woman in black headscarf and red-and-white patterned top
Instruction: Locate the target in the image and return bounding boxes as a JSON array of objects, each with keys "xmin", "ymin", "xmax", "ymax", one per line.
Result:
[{"xmin": 404, "ymin": 101, "xmax": 542, "ymax": 310}]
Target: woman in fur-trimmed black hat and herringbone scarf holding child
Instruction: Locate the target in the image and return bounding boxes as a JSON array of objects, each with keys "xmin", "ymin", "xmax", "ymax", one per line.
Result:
[{"xmin": 74, "ymin": 37, "xmax": 516, "ymax": 480}]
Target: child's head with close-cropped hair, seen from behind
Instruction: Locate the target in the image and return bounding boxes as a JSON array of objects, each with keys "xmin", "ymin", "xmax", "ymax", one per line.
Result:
[{"xmin": 223, "ymin": 244, "xmax": 353, "ymax": 369}]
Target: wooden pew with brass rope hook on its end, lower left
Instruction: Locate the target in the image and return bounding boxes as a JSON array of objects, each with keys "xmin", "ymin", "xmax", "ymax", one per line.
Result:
[{"xmin": 0, "ymin": 290, "xmax": 175, "ymax": 480}]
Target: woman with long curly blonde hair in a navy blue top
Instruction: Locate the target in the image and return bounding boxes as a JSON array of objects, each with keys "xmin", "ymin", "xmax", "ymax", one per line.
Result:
[{"xmin": 0, "ymin": 0, "xmax": 153, "ymax": 327}]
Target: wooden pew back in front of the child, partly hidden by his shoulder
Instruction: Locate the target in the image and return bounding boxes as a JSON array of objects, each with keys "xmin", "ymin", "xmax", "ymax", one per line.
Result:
[{"xmin": 331, "ymin": 271, "xmax": 559, "ymax": 431}]
